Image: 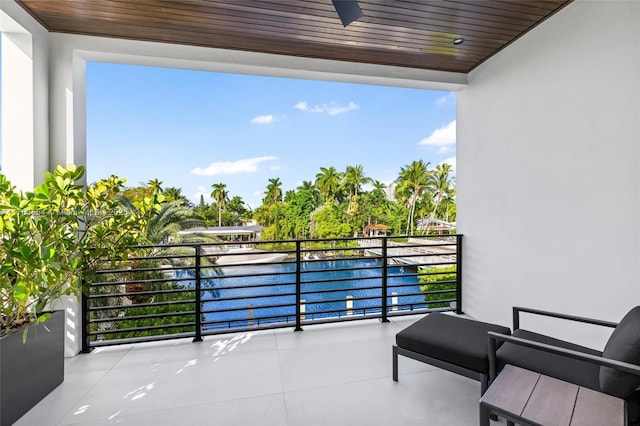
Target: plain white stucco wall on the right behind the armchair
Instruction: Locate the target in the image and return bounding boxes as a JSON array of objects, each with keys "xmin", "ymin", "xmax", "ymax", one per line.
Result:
[{"xmin": 457, "ymin": 0, "xmax": 640, "ymax": 343}]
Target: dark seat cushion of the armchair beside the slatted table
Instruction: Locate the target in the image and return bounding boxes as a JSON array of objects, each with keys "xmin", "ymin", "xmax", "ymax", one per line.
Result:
[{"xmin": 496, "ymin": 329, "xmax": 602, "ymax": 391}]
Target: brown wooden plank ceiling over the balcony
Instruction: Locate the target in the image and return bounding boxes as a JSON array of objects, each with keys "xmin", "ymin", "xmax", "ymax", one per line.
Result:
[{"xmin": 16, "ymin": 0, "xmax": 572, "ymax": 73}]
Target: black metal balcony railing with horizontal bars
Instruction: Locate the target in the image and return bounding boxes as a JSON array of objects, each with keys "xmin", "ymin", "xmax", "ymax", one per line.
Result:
[{"xmin": 82, "ymin": 235, "xmax": 462, "ymax": 352}]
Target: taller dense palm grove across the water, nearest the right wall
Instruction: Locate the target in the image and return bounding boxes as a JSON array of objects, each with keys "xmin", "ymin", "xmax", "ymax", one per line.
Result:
[{"xmin": 253, "ymin": 160, "xmax": 456, "ymax": 240}]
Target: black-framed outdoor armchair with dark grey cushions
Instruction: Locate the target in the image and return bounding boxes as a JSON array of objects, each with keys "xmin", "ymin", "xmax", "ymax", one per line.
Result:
[{"xmin": 488, "ymin": 306, "xmax": 640, "ymax": 424}]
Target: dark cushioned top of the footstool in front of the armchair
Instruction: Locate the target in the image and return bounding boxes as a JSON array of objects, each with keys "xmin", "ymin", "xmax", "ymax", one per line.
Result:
[{"xmin": 396, "ymin": 312, "xmax": 511, "ymax": 373}]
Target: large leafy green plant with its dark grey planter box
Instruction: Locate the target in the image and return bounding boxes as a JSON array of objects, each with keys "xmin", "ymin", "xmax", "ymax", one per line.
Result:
[{"xmin": 0, "ymin": 166, "xmax": 162, "ymax": 426}]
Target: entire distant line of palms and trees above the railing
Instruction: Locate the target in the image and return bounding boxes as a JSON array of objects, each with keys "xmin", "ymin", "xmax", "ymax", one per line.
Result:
[{"xmin": 115, "ymin": 160, "xmax": 456, "ymax": 242}]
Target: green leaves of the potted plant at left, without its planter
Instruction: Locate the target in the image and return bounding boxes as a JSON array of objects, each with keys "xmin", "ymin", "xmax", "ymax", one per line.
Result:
[{"xmin": 0, "ymin": 166, "xmax": 165, "ymax": 335}]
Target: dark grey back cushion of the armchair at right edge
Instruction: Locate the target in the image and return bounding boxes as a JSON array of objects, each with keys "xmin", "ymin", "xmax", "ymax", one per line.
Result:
[{"xmin": 600, "ymin": 306, "xmax": 640, "ymax": 398}]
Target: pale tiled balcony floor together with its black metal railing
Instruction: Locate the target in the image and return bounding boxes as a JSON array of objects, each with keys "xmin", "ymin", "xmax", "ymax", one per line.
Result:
[{"xmin": 12, "ymin": 235, "xmax": 472, "ymax": 425}]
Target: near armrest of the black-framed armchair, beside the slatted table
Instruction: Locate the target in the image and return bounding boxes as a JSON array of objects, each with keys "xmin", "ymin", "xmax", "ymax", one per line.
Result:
[{"xmin": 488, "ymin": 331, "xmax": 640, "ymax": 382}]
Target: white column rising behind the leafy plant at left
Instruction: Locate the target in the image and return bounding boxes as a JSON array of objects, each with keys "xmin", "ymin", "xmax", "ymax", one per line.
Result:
[{"xmin": 0, "ymin": 1, "xmax": 86, "ymax": 356}]
